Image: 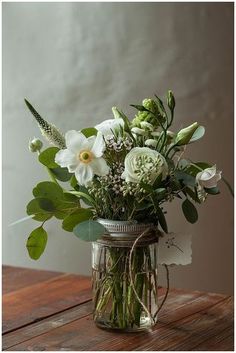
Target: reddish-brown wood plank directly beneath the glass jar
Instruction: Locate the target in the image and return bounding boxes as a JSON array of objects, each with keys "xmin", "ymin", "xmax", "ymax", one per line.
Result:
[{"xmin": 4, "ymin": 290, "xmax": 229, "ymax": 351}]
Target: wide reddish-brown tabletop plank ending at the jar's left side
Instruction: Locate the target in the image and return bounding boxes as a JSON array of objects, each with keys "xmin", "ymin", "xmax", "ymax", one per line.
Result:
[{"xmin": 3, "ymin": 275, "xmax": 91, "ymax": 333}]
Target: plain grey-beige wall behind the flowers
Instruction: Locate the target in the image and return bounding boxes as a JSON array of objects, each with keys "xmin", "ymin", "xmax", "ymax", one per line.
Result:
[{"xmin": 3, "ymin": 3, "xmax": 233, "ymax": 293}]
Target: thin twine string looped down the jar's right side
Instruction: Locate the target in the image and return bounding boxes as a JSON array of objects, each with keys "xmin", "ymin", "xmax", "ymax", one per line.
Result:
[{"xmin": 129, "ymin": 228, "xmax": 170, "ymax": 322}]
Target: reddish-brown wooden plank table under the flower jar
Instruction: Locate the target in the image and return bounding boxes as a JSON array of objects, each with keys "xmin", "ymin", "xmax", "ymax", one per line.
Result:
[{"xmin": 2, "ymin": 266, "xmax": 233, "ymax": 351}]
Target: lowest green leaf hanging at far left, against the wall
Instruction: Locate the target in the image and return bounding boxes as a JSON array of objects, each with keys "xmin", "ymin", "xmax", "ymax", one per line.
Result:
[{"xmin": 26, "ymin": 227, "xmax": 48, "ymax": 260}]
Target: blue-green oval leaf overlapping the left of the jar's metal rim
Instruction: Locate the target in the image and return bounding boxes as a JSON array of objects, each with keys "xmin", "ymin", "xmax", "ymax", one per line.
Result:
[{"xmin": 73, "ymin": 220, "xmax": 105, "ymax": 241}]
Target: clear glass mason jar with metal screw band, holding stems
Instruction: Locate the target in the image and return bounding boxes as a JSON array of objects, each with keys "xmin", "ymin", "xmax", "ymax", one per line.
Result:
[{"xmin": 92, "ymin": 219, "xmax": 158, "ymax": 331}]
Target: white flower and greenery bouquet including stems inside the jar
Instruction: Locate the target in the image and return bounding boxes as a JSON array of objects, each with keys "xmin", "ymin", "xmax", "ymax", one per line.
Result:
[{"xmin": 25, "ymin": 91, "xmax": 227, "ymax": 328}]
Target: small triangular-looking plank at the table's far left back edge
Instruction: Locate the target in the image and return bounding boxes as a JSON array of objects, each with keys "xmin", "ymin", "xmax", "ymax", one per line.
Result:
[{"xmin": 2, "ymin": 266, "xmax": 62, "ymax": 294}]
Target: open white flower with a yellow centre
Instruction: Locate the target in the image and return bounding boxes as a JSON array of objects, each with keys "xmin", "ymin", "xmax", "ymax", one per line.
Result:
[{"xmin": 55, "ymin": 130, "xmax": 109, "ymax": 186}]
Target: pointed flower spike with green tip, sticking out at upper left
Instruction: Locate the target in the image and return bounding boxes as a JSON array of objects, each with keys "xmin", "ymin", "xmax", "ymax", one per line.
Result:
[{"xmin": 25, "ymin": 99, "xmax": 66, "ymax": 148}]
